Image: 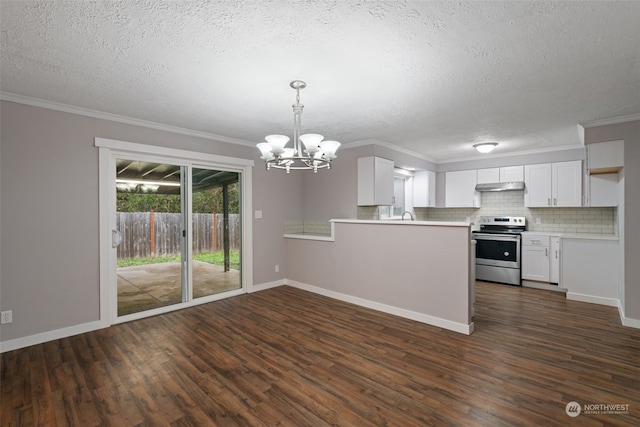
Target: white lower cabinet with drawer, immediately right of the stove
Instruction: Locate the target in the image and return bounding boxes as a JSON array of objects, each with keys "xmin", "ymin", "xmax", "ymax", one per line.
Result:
[{"xmin": 521, "ymin": 234, "xmax": 560, "ymax": 284}]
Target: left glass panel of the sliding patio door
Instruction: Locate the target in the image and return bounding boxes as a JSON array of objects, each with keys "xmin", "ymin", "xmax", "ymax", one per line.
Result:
[{"xmin": 114, "ymin": 158, "xmax": 188, "ymax": 316}]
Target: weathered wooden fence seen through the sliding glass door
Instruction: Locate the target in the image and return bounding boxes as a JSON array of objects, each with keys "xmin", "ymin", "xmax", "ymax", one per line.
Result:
[{"xmin": 116, "ymin": 212, "xmax": 240, "ymax": 259}]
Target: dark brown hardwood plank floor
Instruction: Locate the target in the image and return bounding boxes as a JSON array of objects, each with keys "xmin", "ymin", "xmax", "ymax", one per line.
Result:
[{"xmin": 0, "ymin": 283, "xmax": 640, "ymax": 427}]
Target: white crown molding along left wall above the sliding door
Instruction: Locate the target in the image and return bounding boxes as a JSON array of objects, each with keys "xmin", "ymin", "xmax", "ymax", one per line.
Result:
[{"xmin": 0, "ymin": 92, "xmax": 255, "ymax": 147}]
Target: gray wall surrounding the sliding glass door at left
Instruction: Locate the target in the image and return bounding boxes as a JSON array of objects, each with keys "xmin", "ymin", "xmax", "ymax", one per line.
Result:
[{"xmin": 0, "ymin": 98, "xmax": 302, "ymax": 341}]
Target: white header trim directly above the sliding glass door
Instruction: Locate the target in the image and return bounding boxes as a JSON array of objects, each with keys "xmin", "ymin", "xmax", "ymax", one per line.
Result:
[{"xmin": 94, "ymin": 137, "xmax": 254, "ymax": 166}]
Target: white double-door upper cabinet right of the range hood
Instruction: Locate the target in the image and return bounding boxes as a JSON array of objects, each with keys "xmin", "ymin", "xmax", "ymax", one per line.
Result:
[{"xmin": 524, "ymin": 160, "xmax": 582, "ymax": 208}]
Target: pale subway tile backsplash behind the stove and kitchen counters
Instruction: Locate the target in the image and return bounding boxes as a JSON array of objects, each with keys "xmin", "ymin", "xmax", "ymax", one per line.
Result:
[{"xmin": 412, "ymin": 191, "xmax": 618, "ymax": 234}]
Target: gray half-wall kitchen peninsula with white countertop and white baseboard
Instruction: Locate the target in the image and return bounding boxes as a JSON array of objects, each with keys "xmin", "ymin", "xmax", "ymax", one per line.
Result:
[{"xmin": 285, "ymin": 219, "xmax": 474, "ymax": 334}]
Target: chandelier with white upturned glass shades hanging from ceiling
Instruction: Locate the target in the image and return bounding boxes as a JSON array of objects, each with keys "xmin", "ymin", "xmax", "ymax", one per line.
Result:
[{"xmin": 257, "ymin": 80, "xmax": 340, "ymax": 173}]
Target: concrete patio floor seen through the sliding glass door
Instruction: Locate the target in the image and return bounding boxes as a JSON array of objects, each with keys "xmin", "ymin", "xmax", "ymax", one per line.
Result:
[{"xmin": 118, "ymin": 261, "xmax": 240, "ymax": 316}]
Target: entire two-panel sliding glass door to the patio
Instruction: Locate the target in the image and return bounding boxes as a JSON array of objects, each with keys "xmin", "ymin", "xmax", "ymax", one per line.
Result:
[{"xmin": 112, "ymin": 157, "xmax": 242, "ymax": 318}]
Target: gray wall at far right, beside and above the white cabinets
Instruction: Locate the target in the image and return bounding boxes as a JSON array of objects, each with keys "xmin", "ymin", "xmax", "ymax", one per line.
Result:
[{"xmin": 585, "ymin": 120, "xmax": 640, "ymax": 319}]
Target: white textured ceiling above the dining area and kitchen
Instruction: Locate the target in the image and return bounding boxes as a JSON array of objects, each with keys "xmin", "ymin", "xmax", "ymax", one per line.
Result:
[{"xmin": 0, "ymin": 0, "xmax": 640, "ymax": 161}]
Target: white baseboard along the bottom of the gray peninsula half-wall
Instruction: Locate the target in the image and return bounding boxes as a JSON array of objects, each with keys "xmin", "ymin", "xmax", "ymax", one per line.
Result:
[{"xmin": 286, "ymin": 279, "xmax": 474, "ymax": 335}]
